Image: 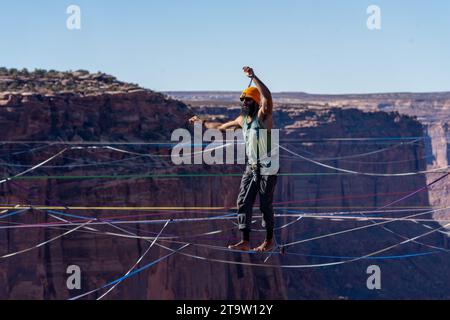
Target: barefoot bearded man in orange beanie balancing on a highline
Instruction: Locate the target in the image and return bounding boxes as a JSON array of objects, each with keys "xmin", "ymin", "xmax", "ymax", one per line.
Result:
[{"xmin": 189, "ymin": 67, "xmax": 277, "ymax": 252}]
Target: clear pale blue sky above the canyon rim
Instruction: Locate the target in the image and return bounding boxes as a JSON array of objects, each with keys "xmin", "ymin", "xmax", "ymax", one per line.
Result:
[{"xmin": 0, "ymin": 0, "xmax": 450, "ymax": 93}]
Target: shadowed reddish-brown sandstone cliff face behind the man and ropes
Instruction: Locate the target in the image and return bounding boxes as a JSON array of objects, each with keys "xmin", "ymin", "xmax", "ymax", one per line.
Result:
[{"xmin": 0, "ymin": 70, "xmax": 450, "ymax": 299}]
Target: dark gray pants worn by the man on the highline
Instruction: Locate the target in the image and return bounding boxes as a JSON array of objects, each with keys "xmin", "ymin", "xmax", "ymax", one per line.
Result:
[{"xmin": 237, "ymin": 165, "xmax": 277, "ymax": 232}]
